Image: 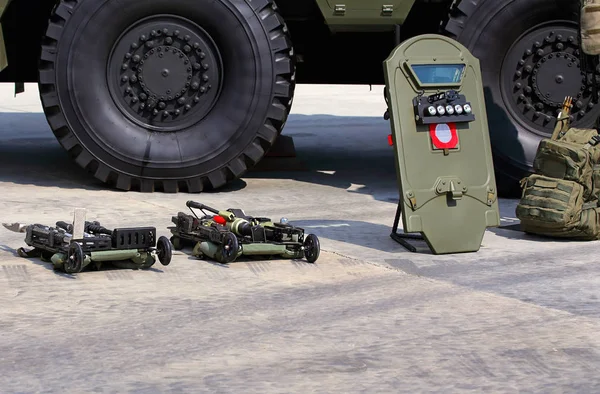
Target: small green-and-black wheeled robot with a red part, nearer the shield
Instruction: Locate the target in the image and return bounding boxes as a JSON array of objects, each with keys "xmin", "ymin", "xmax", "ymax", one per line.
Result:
[{"xmin": 169, "ymin": 201, "xmax": 320, "ymax": 264}]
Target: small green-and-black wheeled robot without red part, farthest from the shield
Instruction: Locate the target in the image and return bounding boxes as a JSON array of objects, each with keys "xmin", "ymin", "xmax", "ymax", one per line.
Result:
[{"xmin": 4, "ymin": 221, "xmax": 172, "ymax": 274}]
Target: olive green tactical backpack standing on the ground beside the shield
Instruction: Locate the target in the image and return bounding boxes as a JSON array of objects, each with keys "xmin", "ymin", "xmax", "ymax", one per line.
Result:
[{"xmin": 516, "ymin": 98, "xmax": 600, "ymax": 240}]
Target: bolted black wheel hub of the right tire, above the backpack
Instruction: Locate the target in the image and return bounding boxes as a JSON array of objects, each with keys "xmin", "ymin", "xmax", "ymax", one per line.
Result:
[{"xmin": 502, "ymin": 22, "xmax": 598, "ymax": 137}]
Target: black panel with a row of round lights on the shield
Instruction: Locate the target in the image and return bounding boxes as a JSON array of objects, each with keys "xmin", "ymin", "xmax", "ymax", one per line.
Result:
[{"xmin": 413, "ymin": 90, "xmax": 475, "ymax": 125}]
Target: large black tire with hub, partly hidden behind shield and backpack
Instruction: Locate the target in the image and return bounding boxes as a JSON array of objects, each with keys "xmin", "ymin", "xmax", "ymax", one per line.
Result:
[{"xmin": 442, "ymin": 0, "xmax": 600, "ymax": 197}]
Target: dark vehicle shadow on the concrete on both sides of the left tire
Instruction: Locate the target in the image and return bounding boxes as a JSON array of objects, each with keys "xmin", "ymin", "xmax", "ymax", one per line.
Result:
[{"xmin": 0, "ymin": 113, "xmax": 404, "ymax": 202}]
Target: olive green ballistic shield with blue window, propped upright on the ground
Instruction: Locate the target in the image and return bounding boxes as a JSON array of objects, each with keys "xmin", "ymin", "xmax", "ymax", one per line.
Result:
[{"xmin": 384, "ymin": 34, "xmax": 500, "ymax": 254}]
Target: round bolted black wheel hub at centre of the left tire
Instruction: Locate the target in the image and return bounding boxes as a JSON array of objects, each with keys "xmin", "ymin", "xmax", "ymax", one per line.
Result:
[{"xmin": 108, "ymin": 16, "xmax": 222, "ymax": 131}]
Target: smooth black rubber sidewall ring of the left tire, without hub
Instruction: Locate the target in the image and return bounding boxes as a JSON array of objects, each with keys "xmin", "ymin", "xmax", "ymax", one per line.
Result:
[{"xmin": 56, "ymin": 0, "xmax": 275, "ymax": 180}]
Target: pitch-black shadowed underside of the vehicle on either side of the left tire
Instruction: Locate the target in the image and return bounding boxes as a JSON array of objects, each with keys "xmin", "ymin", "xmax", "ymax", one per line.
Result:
[{"xmin": 0, "ymin": 0, "xmax": 449, "ymax": 85}]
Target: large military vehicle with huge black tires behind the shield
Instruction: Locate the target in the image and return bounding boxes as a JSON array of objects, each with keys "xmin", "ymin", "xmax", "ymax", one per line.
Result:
[{"xmin": 0, "ymin": 0, "xmax": 600, "ymax": 192}]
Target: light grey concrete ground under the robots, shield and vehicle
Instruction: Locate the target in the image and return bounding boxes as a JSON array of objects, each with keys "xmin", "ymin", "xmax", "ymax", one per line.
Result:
[{"xmin": 0, "ymin": 85, "xmax": 600, "ymax": 393}]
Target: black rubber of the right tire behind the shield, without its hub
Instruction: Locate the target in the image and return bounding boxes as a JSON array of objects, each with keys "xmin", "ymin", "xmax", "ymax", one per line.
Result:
[{"xmin": 446, "ymin": 0, "xmax": 578, "ymax": 195}]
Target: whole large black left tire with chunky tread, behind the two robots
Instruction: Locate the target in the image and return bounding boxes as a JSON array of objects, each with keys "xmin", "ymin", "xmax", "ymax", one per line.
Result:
[{"xmin": 39, "ymin": 0, "xmax": 295, "ymax": 192}]
